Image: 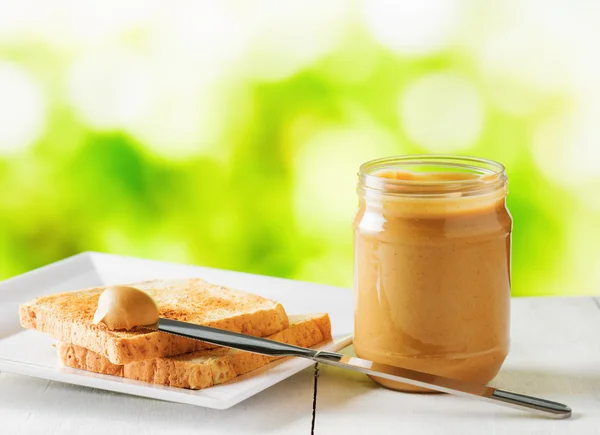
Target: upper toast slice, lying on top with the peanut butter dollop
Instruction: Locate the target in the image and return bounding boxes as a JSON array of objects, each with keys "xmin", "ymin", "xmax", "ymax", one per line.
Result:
[{"xmin": 19, "ymin": 278, "xmax": 288, "ymax": 365}]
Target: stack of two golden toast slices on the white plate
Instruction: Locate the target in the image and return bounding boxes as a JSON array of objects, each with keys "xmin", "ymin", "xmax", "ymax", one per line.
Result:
[{"xmin": 20, "ymin": 278, "xmax": 331, "ymax": 389}]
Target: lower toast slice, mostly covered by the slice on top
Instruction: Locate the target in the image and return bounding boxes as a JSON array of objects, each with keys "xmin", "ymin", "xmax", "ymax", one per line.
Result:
[{"xmin": 57, "ymin": 314, "xmax": 331, "ymax": 390}]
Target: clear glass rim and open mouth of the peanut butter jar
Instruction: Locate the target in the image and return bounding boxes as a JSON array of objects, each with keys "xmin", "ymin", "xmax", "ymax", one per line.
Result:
[{"xmin": 358, "ymin": 155, "xmax": 507, "ymax": 197}]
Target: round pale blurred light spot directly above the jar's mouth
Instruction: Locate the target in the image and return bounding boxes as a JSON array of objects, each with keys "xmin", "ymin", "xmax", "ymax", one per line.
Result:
[{"xmin": 398, "ymin": 72, "xmax": 485, "ymax": 153}]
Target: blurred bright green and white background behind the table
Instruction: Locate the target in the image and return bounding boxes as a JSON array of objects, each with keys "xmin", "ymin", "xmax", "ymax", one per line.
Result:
[{"xmin": 0, "ymin": 0, "xmax": 600, "ymax": 295}]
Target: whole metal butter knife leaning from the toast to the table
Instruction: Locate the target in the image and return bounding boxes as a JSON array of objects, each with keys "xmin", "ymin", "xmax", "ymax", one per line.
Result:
[{"xmin": 158, "ymin": 318, "xmax": 571, "ymax": 419}]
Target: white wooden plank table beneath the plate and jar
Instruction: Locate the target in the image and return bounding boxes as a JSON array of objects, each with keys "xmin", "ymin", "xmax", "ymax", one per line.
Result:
[{"xmin": 0, "ymin": 297, "xmax": 600, "ymax": 435}]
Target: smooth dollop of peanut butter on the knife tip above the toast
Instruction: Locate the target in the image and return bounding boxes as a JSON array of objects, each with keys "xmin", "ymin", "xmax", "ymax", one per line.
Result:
[{"xmin": 94, "ymin": 286, "xmax": 158, "ymax": 330}]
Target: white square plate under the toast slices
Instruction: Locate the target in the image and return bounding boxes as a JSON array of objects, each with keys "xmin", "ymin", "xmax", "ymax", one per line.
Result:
[{"xmin": 0, "ymin": 252, "xmax": 353, "ymax": 409}]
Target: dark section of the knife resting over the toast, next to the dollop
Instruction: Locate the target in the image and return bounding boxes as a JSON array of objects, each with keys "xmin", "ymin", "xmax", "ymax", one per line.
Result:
[{"xmin": 158, "ymin": 318, "xmax": 317, "ymax": 358}]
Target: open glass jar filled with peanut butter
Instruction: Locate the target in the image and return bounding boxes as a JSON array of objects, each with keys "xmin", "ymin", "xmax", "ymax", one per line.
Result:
[{"xmin": 354, "ymin": 156, "xmax": 512, "ymax": 392}]
